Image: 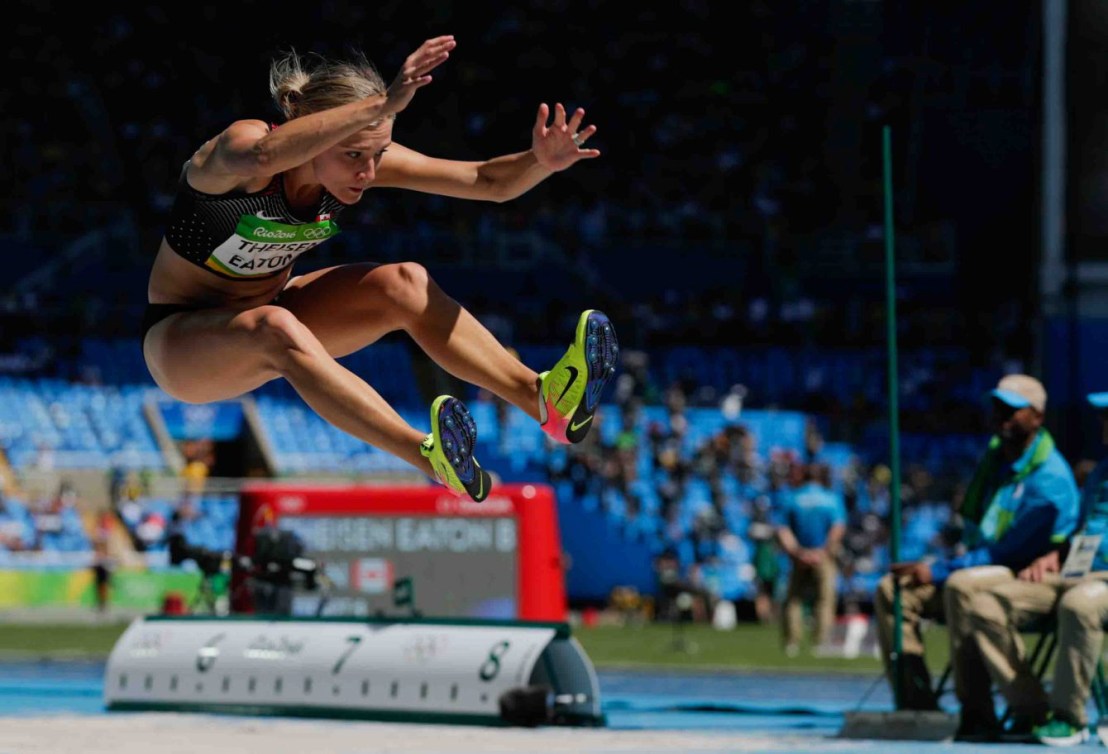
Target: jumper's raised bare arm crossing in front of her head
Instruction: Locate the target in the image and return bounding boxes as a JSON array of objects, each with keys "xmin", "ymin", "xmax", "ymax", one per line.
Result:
[{"xmin": 188, "ymin": 37, "xmax": 456, "ymax": 194}]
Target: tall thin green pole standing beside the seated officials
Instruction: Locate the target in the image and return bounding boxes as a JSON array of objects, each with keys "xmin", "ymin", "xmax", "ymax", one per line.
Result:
[{"xmin": 882, "ymin": 126, "xmax": 904, "ymax": 710}]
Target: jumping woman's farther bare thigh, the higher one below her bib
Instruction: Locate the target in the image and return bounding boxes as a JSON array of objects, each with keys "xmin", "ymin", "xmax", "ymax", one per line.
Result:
[{"xmin": 278, "ymin": 262, "xmax": 399, "ymax": 358}]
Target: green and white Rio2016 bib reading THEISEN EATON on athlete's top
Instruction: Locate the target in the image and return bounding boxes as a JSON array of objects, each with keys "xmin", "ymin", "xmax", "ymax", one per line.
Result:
[{"xmin": 205, "ymin": 213, "xmax": 339, "ymax": 278}]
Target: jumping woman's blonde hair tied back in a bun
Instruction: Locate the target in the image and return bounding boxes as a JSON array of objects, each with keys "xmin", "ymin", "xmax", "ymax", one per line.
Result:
[{"xmin": 269, "ymin": 50, "xmax": 388, "ymax": 121}]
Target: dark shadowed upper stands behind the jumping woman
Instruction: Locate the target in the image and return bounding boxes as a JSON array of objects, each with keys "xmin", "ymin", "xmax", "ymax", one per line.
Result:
[{"xmin": 0, "ymin": 0, "xmax": 1105, "ymax": 453}]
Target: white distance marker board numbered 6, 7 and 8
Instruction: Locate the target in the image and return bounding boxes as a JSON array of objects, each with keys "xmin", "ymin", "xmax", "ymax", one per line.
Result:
[{"xmin": 104, "ymin": 617, "xmax": 604, "ymax": 725}]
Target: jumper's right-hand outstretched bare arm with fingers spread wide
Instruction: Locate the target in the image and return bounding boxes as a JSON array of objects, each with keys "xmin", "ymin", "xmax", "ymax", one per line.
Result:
[{"xmin": 373, "ymin": 103, "xmax": 601, "ymax": 202}]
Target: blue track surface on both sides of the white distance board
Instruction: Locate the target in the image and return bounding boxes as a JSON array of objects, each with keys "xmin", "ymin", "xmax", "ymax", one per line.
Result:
[{"xmin": 0, "ymin": 661, "xmax": 1096, "ymax": 754}]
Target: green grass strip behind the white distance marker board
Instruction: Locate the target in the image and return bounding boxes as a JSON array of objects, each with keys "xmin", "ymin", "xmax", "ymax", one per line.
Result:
[{"xmin": 0, "ymin": 623, "xmax": 947, "ymax": 674}]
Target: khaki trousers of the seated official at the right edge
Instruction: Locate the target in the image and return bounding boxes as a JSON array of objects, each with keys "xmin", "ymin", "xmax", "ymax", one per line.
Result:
[{"xmin": 970, "ymin": 571, "xmax": 1108, "ymax": 724}]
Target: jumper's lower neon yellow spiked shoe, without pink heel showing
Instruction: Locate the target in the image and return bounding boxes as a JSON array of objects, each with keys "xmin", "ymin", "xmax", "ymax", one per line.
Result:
[{"xmin": 419, "ymin": 395, "xmax": 492, "ymax": 503}]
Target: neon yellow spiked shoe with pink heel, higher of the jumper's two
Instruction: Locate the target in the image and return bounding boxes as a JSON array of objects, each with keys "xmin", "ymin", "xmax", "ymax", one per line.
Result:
[{"xmin": 538, "ymin": 309, "xmax": 619, "ymax": 443}]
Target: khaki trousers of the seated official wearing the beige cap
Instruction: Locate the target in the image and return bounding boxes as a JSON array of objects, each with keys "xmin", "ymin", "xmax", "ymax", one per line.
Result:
[{"xmin": 874, "ymin": 566, "xmax": 1015, "ymax": 699}]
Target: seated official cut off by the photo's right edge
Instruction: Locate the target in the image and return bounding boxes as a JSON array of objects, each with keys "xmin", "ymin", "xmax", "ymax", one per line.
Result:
[{"xmin": 962, "ymin": 393, "xmax": 1108, "ymax": 745}]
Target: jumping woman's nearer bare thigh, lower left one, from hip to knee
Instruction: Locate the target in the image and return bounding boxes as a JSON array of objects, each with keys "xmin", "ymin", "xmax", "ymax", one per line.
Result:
[{"xmin": 143, "ymin": 309, "xmax": 278, "ymax": 403}]
